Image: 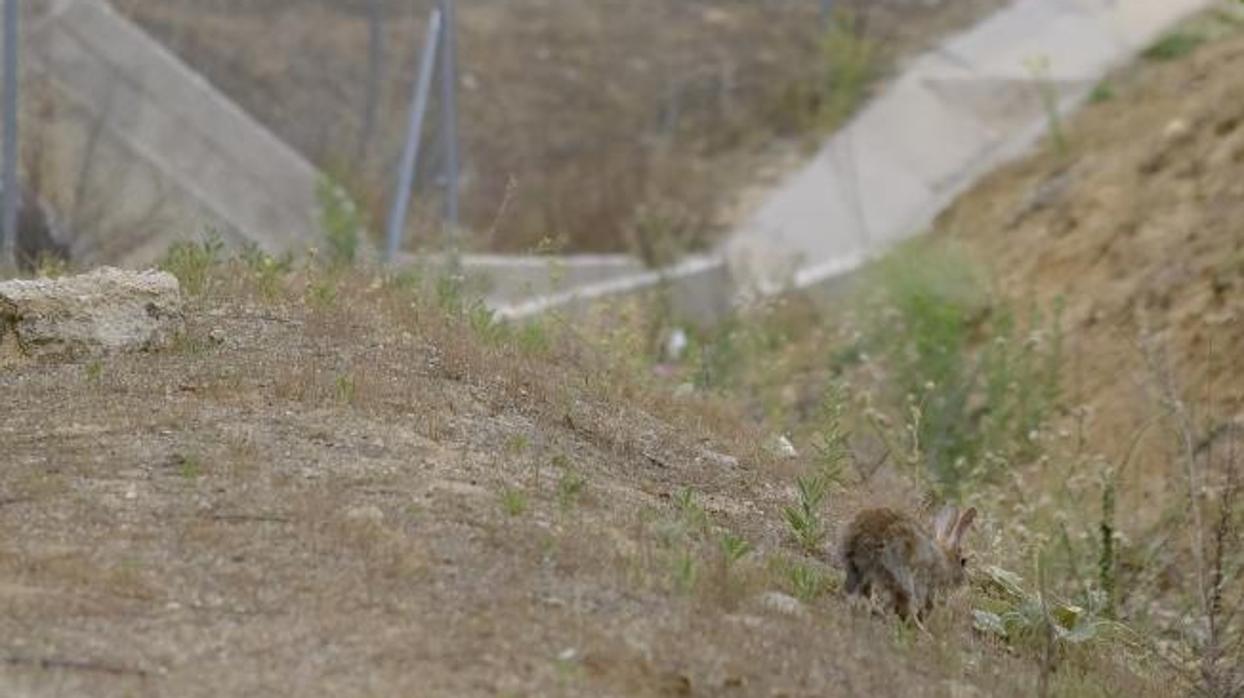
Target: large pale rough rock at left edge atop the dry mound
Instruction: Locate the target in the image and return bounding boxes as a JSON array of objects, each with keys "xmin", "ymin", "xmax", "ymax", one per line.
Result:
[{"xmin": 0, "ymin": 268, "xmax": 184, "ymax": 365}]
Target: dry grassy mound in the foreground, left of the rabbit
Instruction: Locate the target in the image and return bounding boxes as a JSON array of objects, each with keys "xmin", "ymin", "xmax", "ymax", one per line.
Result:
[{"xmin": 0, "ymin": 252, "xmax": 1167, "ymax": 696}]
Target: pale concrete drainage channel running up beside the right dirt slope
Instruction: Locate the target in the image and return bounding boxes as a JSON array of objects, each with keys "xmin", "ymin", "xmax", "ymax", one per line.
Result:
[{"xmin": 491, "ymin": 0, "xmax": 1215, "ymax": 323}]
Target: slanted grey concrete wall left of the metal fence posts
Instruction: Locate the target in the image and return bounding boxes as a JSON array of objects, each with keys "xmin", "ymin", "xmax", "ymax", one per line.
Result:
[{"xmin": 22, "ymin": 0, "xmax": 317, "ymax": 266}]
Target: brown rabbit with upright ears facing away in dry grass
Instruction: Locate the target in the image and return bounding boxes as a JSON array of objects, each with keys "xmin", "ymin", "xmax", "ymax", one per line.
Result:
[{"xmin": 841, "ymin": 506, "xmax": 977, "ymax": 627}]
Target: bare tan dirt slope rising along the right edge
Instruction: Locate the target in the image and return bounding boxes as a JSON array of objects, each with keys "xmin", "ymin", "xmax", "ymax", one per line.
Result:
[{"xmin": 938, "ymin": 19, "xmax": 1244, "ymax": 486}]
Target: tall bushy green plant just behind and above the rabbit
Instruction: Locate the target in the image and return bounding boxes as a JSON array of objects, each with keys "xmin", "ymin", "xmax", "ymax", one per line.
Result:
[{"xmin": 868, "ymin": 243, "xmax": 1062, "ymax": 500}]
